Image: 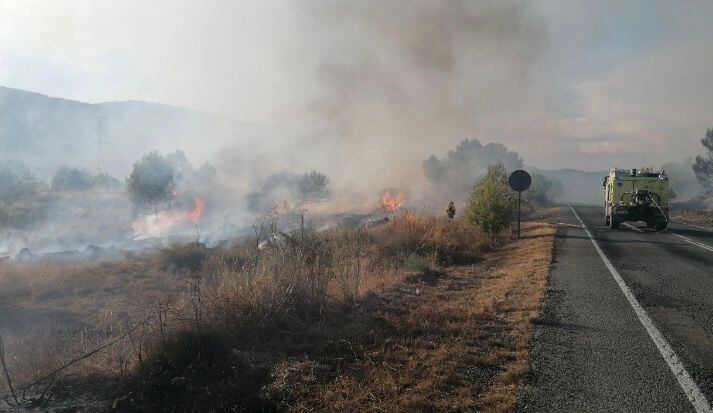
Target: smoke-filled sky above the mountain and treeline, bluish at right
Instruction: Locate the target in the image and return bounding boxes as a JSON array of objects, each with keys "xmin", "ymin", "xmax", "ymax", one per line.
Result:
[{"xmin": 0, "ymin": 0, "xmax": 713, "ymax": 172}]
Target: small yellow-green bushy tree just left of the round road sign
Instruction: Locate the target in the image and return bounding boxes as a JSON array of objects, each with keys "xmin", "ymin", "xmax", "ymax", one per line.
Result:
[{"xmin": 466, "ymin": 163, "xmax": 517, "ymax": 236}]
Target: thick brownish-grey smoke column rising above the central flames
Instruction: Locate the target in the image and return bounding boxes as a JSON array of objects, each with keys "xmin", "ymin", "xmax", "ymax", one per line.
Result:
[{"xmin": 276, "ymin": 0, "xmax": 547, "ymax": 192}]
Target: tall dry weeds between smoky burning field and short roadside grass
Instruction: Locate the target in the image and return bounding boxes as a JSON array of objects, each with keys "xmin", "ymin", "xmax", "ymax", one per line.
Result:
[{"xmin": 0, "ymin": 212, "xmax": 494, "ymax": 410}]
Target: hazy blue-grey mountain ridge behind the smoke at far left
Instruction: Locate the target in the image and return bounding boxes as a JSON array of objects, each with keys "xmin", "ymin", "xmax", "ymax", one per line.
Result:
[{"xmin": 0, "ymin": 87, "xmax": 238, "ymax": 179}]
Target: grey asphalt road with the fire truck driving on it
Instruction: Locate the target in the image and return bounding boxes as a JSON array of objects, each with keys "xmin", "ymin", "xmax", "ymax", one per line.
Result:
[{"xmin": 519, "ymin": 206, "xmax": 713, "ymax": 412}]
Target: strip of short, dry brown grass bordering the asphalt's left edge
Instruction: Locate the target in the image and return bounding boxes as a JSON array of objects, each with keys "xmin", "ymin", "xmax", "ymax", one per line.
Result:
[{"xmin": 268, "ymin": 220, "xmax": 555, "ymax": 412}]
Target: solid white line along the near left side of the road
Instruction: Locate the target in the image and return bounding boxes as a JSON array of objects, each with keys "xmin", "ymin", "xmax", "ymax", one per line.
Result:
[{"xmin": 569, "ymin": 205, "xmax": 713, "ymax": 413}]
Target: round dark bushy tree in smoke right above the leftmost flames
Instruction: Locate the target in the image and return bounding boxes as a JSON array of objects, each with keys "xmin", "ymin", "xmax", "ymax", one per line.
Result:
[{"xmin": 126, "ymin": 151, "xmax": 176, "ymax": 210}]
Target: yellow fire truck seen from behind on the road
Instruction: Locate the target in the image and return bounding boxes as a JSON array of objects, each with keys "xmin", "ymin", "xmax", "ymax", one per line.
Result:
[{"xmin": 602, "ymin": 168, "xmax": 671, "ymax": 231}]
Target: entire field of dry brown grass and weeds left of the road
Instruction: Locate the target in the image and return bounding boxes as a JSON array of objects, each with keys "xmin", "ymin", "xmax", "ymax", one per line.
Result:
[{"xmin": 0, "ymin": 213, "xmax": 554, "ymax": 411}]
